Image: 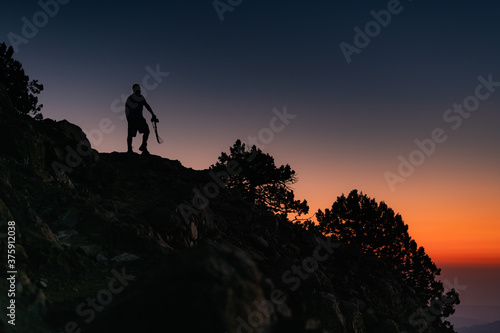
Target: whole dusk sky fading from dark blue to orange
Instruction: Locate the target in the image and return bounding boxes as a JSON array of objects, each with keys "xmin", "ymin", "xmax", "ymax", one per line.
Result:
[{"xmin": 0, "ymin": 0, "xmax": 500, "ymax": 319}]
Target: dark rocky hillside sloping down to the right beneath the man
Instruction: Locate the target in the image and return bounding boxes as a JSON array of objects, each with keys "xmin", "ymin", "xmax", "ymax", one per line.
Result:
[{"xmin": 0, "ymin": 108, "xmax": 454, "ymax": 333}]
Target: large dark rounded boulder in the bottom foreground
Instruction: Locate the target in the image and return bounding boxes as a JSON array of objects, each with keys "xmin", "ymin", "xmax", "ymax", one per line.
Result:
[{"xmin": 88, "ymin": 243, "xmax": 271, "ymax": 333}]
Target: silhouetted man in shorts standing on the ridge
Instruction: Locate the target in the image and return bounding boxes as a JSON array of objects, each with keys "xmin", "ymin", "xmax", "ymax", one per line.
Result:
[{"xmin": 125, "ymin": 84, "xmax": 158, "ymax": 155}]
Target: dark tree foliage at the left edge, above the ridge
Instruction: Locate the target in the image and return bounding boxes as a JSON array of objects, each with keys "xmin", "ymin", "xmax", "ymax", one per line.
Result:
[{"xmin": 0, "ymin": 43, "xmax": 43, "ymax": 120}]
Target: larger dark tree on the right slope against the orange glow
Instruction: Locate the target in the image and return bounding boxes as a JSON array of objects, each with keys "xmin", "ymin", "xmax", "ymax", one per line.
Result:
[{"xmin": 316, "ymin": 190, "xmax": 459, "ymax": 317}]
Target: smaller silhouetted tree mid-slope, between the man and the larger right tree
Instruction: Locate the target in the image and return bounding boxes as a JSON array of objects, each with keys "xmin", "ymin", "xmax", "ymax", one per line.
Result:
[{"xmin": 211, "ymin": 140, "xmax": 309, "ymax": 215}]
